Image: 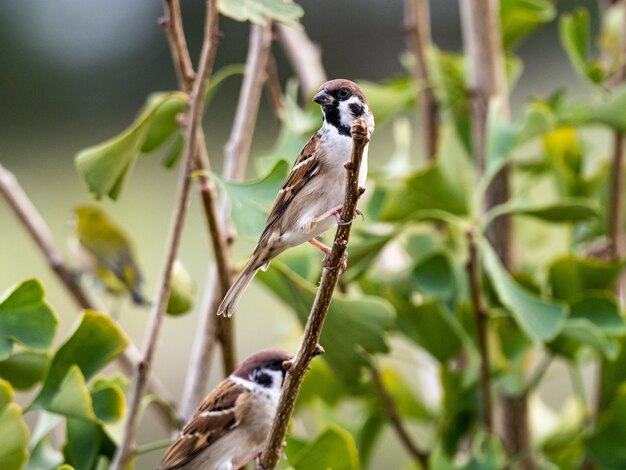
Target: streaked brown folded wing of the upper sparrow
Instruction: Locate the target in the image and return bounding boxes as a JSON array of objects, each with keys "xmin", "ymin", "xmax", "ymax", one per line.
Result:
[{"xmin": 260, "ymin": 133, "xmax": 320, "ymax": 240}]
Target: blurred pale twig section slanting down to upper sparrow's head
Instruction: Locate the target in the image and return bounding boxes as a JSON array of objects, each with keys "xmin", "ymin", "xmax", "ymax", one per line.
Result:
[{"xmin": 277, "ymin": 24, "xmax": 327, "ymax": 98}]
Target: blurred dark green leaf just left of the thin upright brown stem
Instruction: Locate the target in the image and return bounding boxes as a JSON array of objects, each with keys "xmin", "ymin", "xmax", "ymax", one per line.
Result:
[{"xmin": 398, "ymin": 302, "xmax": 463, "ymax": 364}]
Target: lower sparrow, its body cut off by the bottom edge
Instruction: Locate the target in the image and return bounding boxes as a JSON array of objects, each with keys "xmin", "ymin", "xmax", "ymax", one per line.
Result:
[{"xmin": 159, "ymin": 349, "xmax": 291, "ymax": 470}]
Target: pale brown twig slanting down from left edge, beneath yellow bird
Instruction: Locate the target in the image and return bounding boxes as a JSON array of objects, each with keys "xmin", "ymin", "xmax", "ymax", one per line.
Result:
[{"xmin": 0, "ymin": 165, "xmax": 174, "ymax": 429}]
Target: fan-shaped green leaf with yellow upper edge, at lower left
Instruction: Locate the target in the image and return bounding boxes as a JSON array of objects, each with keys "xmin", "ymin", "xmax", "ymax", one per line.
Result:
[{"xmin": 33, "ymin": 310, "xmax": 128, "ymax": 408}]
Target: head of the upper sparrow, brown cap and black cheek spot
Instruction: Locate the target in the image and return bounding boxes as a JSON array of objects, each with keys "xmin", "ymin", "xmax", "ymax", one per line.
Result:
[{"xmin": 313, "ymin": 79, "xmax": 374, "ymax": 137}]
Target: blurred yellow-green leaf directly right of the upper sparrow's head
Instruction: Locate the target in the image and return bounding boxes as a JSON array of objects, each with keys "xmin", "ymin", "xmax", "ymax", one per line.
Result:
[{"xmin": 359, "ymin": 77, "xmax": 417, "ymax": 125}]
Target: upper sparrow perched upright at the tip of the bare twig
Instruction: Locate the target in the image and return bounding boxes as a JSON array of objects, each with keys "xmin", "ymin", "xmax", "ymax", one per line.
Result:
[{"xmin": 217, "ymin": 80, "xmax": 374, "ymax": 317}]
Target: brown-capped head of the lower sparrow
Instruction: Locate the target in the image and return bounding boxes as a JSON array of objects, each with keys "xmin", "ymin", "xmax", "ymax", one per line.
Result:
[{"xmin": 233, "ymin": 349, "xmax": 292, "ymax": 391}]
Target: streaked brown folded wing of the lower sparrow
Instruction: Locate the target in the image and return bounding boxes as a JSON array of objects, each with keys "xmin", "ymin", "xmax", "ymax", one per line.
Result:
[{"xmin": 159, "ymin": 379, "xmax": 249, "ymax": 470}]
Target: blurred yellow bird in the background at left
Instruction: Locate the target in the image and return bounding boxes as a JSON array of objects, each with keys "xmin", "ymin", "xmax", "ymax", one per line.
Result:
[{"xmin": 70, "ymin": 206, "xmax": 148, "ymax": 305}]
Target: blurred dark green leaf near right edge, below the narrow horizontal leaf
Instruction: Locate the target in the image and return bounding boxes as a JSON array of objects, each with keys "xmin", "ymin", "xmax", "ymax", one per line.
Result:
[{"xmin": 548, "ymin": 256, "xmax": 623, "ymax": 301}]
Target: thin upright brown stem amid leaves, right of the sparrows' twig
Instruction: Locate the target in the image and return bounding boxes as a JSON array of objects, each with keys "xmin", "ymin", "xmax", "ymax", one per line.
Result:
[{"xmin": 467, "ymin": 231, "xmax": 493, "ymax": 432}]
